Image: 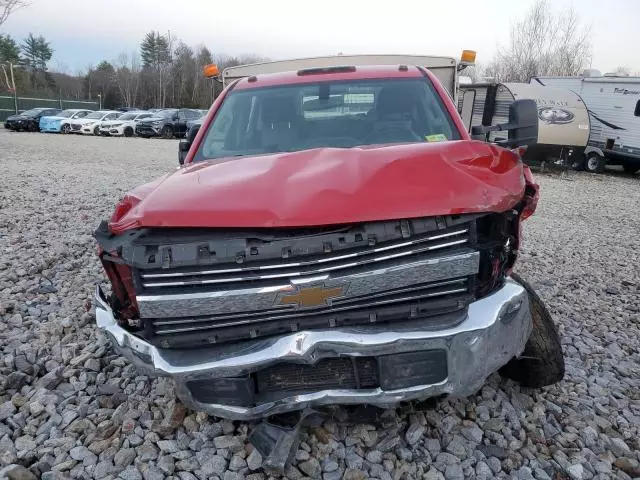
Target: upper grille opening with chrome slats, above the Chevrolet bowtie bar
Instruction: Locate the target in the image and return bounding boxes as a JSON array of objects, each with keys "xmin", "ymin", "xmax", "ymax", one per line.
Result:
[{"xmin": 140, "ymin": 228, "xmax": 469, "ymax": 289}]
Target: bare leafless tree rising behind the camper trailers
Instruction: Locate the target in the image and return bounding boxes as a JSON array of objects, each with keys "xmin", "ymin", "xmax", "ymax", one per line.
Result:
[{"xmin": 487, "ymin": 0, "xmax": 592, "ymax": 82}]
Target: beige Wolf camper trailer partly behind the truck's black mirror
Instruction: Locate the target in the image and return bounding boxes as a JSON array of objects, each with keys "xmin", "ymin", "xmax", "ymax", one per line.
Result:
[{"xmin": 458, "ymin": 83, "xmax": 589, "ymax": 167}]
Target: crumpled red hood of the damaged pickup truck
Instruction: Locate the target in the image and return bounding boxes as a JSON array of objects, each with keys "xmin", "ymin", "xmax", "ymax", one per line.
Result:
[{"xmin": 109, "ymin": 140, "xmax": 525, "ymax": 233}]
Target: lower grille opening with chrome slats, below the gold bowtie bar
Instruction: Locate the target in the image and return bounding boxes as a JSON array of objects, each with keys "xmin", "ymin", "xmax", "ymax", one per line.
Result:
[{"xmin": 145, "ymin": 277, "xmax": 473, "ymax": 348}]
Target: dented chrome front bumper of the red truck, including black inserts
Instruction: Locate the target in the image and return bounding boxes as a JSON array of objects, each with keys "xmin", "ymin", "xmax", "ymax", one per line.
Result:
[{"xmin": 96, "ymin": 279, "xmax": 532, "ymax": 420}]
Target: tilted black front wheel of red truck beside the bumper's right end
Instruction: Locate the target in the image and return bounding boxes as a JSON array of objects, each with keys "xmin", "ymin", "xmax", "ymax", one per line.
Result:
[{"xmin": 500, "ymin": 273, "xmax": 564, "ymax": 388}]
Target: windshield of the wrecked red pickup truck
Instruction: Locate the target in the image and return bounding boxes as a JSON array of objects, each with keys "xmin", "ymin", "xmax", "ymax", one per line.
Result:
[{"xmin": 194, "ymin": 78, "xmax": 460, "ymax": 161}]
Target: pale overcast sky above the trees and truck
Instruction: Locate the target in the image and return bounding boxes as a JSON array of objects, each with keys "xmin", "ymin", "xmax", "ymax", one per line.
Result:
[{"xmin": 0, "ymin": 0, "xmax": 640, "ymax": 73}]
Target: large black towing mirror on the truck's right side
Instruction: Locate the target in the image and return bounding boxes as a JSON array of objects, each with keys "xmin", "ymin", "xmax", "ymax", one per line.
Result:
[{"xmin": 471, "ymin": 99, "xmax": 538, "ymax": 148}]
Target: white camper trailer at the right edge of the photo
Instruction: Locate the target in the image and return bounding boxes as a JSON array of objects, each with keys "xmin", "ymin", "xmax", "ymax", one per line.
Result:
[{"xmin": 531, "ymin": 70, "xmax": 640, "ymax": 173}]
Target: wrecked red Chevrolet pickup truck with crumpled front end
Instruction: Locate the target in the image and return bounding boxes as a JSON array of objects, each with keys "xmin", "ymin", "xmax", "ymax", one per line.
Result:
[{"xmin": 95, "ymin": 65, "xmax": 564, "ymax": 419}]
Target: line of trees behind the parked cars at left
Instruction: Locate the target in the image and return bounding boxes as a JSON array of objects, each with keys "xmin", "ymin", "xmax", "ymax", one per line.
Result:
[{"xmin": 0, "ymin": 27, "xmax": 265, "ymax": 108}]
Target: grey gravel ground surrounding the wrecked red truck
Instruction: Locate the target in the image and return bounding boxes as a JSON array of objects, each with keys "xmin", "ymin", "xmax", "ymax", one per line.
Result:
[{"xmin": 0, "ymin": 130, "xmax": 640, "ymax": 480}]
